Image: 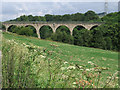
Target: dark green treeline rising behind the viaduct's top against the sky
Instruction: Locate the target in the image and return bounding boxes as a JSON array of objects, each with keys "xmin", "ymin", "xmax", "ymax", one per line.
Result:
[{"xmin": 10, "ymin": 11, "xmax": 101, "ymax": 22}]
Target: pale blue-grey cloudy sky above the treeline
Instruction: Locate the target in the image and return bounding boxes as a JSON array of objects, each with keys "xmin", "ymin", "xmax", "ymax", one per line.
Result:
[{"xmin": 0, "ymin": 0, "xmax": 118, "ymax": 21}]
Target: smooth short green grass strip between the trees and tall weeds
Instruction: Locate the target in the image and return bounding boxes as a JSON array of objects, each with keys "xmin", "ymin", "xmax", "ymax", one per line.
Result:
[{"xmin": 3, "ymin": 33, "xmax": 118, "ymax": 76}]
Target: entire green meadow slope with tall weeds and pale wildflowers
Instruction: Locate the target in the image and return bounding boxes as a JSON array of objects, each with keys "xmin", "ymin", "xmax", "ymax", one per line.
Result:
[{"xmin": 2, "ymin": 33, "xmax": 118, "ymax": 88}]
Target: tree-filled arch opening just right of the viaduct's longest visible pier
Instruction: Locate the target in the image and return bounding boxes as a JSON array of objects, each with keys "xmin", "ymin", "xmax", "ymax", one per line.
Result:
[{"xmin": 39, "ymin": 25, "xmax": 53, "ymax": 39}]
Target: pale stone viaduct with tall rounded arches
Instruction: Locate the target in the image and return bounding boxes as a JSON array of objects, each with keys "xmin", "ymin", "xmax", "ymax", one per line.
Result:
[{"xmin": 2, "ymin": 22, "xmax": 101, "ymax": 38}]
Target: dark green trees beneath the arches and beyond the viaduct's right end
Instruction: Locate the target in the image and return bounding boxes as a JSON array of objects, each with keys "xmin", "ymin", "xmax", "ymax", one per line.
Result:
[{"xmin": 5, "ymin": 12, "xmax": 120, "ymax": 51}]
